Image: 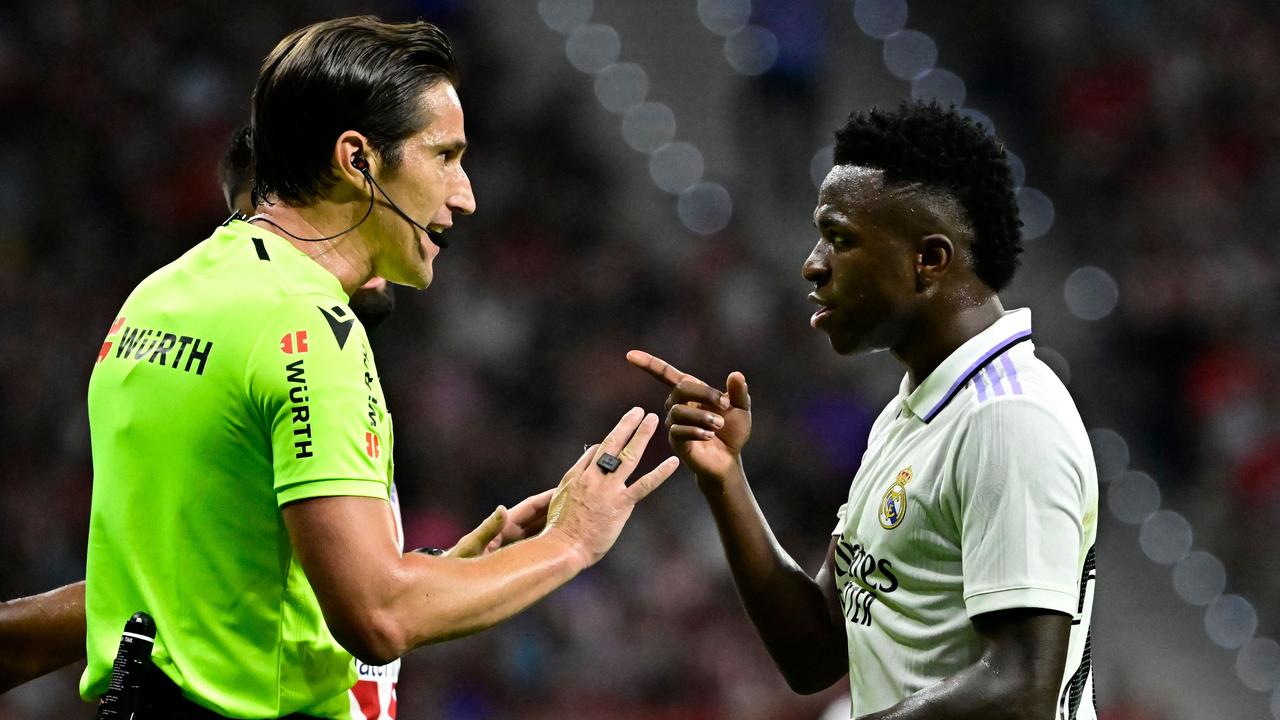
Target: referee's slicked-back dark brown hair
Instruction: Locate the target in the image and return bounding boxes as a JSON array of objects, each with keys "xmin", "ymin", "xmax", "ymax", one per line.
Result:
[{"xmin": 253, "ymin": 15, "xmax": 458, "ymax": 205}]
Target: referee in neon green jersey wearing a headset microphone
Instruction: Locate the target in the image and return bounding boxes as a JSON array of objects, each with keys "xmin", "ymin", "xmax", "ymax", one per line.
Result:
[{"xmin": 81, "ymin": 17, "xmax": 677, "ymax": 719}]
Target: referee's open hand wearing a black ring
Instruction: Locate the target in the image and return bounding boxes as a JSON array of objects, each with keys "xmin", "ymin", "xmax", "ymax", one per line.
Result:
[{"xmin": 545, "ymin": 407, "xmax": 680, "ymax": 565}]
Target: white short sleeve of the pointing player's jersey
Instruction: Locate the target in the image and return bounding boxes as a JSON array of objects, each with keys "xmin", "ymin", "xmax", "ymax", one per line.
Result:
[{"xmin": 955, "ymin": 398, "xmax": 1089, "ymax": 618}]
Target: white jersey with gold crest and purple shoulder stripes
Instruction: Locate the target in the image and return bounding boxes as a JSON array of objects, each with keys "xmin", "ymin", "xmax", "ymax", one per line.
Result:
[{"xmin": 833, "ymin": 309, "xmax": 1098, "ymax": 720}]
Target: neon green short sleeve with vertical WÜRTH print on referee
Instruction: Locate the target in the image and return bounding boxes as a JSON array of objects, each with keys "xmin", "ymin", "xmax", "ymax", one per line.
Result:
[{"xmin": 246, "ymin": 296, "xmax": 389, "ymax": 505}]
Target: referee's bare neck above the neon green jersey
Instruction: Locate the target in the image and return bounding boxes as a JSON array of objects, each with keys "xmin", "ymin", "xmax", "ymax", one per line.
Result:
[{"xmin": 253, "ymin": 201, "xmax": 372, "ymax": 296}]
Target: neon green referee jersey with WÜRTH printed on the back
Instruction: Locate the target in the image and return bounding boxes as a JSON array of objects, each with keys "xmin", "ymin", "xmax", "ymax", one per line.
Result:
[{"xmin": 81, "ymin": 220, "xmax": 392, "ymax": 717}]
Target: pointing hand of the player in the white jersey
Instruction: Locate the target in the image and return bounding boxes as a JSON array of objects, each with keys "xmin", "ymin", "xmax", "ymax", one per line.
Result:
[{"xmin": 627, "ymin": 350, "xmax": 751, "ymax": 480}]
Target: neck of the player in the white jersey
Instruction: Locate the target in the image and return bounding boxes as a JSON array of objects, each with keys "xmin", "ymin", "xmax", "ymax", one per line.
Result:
[{"xmin": 892, "ymin": 293, "xmax": 1005, "ymax": 389}]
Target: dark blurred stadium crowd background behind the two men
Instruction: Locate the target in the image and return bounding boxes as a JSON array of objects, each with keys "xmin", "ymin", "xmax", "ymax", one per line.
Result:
[{"xmin": 0, "ymin": 0, "xmax": 1280, "ymax": 720}]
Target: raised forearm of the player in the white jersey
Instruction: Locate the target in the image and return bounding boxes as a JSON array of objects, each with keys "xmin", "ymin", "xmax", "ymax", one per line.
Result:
[{"xmin": 698, "ymin": 464, "xmax": 849, "ymax": 693}]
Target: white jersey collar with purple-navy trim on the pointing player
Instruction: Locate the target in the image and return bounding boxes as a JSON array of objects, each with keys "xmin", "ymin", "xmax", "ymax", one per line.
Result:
[{"xmin": 899, "ymin": 307, "xmax": 1032, "ymax": 423}]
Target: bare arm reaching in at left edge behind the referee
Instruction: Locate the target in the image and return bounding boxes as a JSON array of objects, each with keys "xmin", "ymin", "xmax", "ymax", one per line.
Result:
[{"xmin": 0, "ymin": 582, "xmax": 84, "ymax": 692}]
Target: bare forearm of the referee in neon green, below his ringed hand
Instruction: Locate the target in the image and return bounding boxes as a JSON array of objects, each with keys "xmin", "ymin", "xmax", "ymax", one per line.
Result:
[{"xmin": 360, "ymin": 532, "xmax": 586, "ymax": 660}]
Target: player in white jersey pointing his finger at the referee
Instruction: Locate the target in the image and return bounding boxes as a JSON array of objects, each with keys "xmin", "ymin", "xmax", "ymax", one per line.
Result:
[{"xmin": 627, "ymin": 102, "xmax": 1097, "ymax": 720}]
